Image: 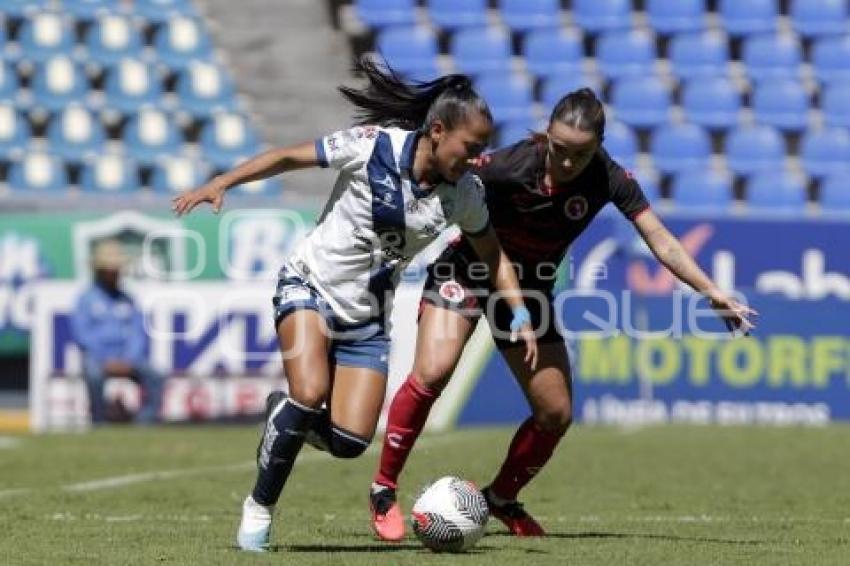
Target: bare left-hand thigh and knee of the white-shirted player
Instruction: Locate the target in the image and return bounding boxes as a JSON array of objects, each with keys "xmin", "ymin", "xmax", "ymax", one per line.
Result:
[{"xmin": 277, "ymin": 309, "xmax": 330, "ymax": 408}]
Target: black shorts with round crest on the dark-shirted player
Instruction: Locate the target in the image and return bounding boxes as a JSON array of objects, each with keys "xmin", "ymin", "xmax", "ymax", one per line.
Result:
[{"xmin": 419, "ymin": 246, "xmax": 564, "ymax": 350}]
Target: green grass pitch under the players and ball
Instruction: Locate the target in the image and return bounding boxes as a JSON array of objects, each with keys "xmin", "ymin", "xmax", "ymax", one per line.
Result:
[{"xmin": 0, "ymin": 427, "xmax": 850, "ymax": 566}]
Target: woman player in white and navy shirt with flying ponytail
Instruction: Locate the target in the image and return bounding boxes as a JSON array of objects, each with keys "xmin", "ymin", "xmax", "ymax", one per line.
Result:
[{"xmin": 169, "ymin": 62, "xmax": 537, "ymax": 551}]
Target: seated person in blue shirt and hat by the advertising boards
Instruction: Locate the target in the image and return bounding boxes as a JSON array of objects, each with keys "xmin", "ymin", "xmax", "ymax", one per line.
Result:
[{"xmin": 71, "ymin": 240, "xmax": 164, "ymax": 424}]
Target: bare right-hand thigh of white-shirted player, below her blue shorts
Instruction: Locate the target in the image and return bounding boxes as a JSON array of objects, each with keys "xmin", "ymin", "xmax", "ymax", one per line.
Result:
[{"xmin": 330, "ymin": 365, "xmax": 387, "ymax": 438}]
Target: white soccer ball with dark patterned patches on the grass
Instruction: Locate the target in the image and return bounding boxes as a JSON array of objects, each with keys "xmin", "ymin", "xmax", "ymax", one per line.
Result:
[{"xmin": 410, "ymin": 476, "xmax": 490, "ymax": 552}]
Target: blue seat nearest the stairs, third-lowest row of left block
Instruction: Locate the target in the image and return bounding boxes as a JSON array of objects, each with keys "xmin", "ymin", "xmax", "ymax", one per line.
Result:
[{"xmin": 175, "ymin": 61, "xmax": 237, "ymax": 119}]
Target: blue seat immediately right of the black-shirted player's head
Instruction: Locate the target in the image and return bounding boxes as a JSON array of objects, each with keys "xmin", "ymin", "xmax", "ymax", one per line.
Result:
[{"xmin": 611, "ymin": 76, "xmax": 670, "ymax": 128}]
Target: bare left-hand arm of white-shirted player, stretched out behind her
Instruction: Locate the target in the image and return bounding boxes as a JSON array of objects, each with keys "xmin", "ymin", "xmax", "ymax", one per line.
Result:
[{"xmin": 171, "ymin": 142, "xmax": 319, "ymax": 216}]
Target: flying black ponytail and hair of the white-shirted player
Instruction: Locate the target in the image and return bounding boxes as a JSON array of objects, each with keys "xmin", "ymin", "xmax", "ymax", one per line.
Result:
[{"xmin": 339, "ymin": 57, "xmax": 486, "ymax": 131}]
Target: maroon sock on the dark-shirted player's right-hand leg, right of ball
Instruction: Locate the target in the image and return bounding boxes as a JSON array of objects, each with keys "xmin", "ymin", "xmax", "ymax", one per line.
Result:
[{"xmin": 490, "ymin": 417, "xmax": 562, "ymax": 501}]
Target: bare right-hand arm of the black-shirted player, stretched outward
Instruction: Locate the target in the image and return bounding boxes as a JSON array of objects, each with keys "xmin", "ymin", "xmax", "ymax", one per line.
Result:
[{"xmin": 635, "ymin": 210, "xmax": 758, "ymax": 334}]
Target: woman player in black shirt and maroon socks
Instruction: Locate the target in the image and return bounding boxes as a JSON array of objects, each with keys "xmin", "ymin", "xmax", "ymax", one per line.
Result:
[{"xmin": 370, "ymin": 89, "xmax": 755, "ymax": 540}]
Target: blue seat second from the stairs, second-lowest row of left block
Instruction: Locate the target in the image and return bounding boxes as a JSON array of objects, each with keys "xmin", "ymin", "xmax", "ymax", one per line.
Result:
[{"xmin": 122, "ymin": 108, "xmax": 183, "ymax": 166}]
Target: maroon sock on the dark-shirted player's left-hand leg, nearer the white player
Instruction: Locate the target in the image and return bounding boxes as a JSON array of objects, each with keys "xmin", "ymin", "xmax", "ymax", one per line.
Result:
[{"xmin": 375, "ymin": 374, "xmax": 440, "ymax": 489}]
